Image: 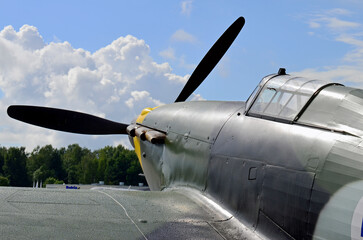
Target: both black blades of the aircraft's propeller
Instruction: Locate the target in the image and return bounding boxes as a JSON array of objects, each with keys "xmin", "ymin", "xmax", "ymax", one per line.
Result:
[{"xmin": 8, "ymin": 17, "xmax": 245, "ymax": 135}]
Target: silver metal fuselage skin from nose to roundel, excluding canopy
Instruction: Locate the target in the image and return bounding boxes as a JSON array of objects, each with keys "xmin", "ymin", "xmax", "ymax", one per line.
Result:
[{"xmin": 133, "ymin": 75, "xmax": 363, "ymax": 239}]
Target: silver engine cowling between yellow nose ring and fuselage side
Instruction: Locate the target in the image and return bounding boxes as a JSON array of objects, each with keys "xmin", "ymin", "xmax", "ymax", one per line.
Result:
[{"xmin": 141, "ymin": 101, "xmax": 243, "ymax": 190}]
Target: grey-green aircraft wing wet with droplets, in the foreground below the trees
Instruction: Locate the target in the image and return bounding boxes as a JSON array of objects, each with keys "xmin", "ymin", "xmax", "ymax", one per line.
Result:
[{"xmin": 0, "ymin": 187, "xmax": 260, "ymax": 240}]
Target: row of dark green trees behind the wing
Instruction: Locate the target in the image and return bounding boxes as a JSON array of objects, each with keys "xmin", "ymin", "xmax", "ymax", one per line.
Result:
[{"xmin": 0, "ymin": 144, "xmax": 146, "ymax": 187}]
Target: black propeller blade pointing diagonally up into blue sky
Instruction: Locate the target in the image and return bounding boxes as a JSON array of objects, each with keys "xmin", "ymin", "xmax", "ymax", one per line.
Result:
[{"xmin": 175, "ymin": 17, "xmax": 245, "ymax": 102}]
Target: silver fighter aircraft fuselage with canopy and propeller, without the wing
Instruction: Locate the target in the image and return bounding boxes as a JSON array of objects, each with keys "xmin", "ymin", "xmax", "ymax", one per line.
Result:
[{"xmin": 8, "ymin": 17, "xmax": 363, "ymax": 239}]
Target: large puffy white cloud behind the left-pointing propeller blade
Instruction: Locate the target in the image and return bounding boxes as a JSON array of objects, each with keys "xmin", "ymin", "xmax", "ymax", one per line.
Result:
[{"xmin": 0, "ymin": 25, "xmax": 187, "ymax": 150}]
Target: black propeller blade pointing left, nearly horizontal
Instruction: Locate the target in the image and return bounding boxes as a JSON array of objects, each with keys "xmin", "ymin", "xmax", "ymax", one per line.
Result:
[{"xmin": 8, "ymin": 105, "xmax": 128, "ymax": 135}]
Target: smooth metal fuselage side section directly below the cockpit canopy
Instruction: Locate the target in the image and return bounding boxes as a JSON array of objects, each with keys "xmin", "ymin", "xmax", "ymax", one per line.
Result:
[{"xmin": 213, "ymin": 111, "xmax": 333, "ymax": 239}]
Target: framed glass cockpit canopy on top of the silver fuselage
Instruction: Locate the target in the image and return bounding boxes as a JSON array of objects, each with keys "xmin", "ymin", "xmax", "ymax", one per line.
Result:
[{"xmin": 246, "ymin": 74, "xmax": 340, "ymax": 122}]
